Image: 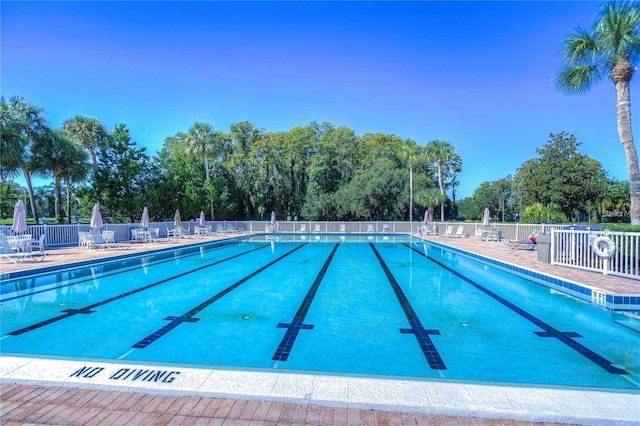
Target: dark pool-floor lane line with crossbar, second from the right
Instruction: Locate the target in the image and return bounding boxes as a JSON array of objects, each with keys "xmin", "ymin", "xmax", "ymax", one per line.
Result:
[{"xmin": 369, "ymin": 243, "xmax": 447, "ymax": 370}]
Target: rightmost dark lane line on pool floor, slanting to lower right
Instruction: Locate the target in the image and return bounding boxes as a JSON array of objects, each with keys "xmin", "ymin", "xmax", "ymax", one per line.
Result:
[{"xmin": 403, "ymin": 243, "xmax": 629, "ymax": 374}]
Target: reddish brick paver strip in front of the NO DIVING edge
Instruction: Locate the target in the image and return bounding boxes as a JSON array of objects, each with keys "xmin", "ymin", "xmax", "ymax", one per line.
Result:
[{"xmin": 0, "ymin": 385, "xmax": 568, "ymax": 426}]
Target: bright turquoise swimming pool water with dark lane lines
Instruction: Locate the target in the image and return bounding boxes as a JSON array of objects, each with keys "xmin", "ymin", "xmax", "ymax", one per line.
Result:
[{"xmin": 0, "ymin": 235, "xmax": 640, "ymax": 392}]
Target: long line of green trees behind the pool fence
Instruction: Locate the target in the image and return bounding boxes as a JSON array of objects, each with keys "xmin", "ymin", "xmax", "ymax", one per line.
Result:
[{"xmin": 0, "ymin": 97, "xmax": 629, "ymax": 223}]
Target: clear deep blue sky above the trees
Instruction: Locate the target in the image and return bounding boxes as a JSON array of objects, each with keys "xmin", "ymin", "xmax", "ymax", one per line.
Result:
[{"xmin": 0, "ymin": 1, "xmax": 640, "ymax": 198}]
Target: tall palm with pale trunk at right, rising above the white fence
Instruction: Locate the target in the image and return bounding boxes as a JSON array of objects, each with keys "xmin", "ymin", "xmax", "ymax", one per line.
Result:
[{"xmin": 556, "ymin": 2, "xmax": 640, "ymax": 225}]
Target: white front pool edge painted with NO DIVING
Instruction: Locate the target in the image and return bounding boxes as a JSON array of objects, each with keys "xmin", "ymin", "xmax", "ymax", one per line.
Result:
[{"xmin": 0, "ymin": 356, "xmax": 640, "ymax": 425}]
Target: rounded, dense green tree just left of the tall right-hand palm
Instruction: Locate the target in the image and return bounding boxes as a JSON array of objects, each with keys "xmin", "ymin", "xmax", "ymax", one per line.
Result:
[{"xmin": 514, "ymin": 132, "xmax": 606, "ymax": 217}]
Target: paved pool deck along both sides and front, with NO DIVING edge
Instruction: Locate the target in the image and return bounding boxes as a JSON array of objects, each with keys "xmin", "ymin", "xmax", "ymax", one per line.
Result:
[{"xmin": 0, "ymin": 236, "xmax": 640, "ymax": 425}]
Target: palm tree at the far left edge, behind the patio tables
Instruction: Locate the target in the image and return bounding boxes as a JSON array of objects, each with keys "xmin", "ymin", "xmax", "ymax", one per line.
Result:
[{"xmin": 0, "ymin": 96, "xmax": 50, "ymax": 223}]
